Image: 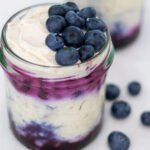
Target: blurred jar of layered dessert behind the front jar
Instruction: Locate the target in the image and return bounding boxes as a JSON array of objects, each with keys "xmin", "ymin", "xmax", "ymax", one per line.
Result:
[{"xmin": 73, "ymin": 0, "xmax": 143, "ymax": 48}]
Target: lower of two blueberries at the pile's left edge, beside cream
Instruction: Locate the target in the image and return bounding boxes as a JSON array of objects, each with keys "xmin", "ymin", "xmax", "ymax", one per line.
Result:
[{"xmin": 46, "ymin": 34, "xmax": 64, "ymax": 51}]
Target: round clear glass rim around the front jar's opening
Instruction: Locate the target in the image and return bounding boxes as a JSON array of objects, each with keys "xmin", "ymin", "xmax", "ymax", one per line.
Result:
[{"xmin": 1, "ymin": 3, "xmax": 110, "ymax": 68}]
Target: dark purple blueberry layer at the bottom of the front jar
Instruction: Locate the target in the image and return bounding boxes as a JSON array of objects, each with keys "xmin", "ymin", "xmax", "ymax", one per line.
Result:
[{"xmin": 9, "ymin": 115, "xmax": 103, "ymax": 150}]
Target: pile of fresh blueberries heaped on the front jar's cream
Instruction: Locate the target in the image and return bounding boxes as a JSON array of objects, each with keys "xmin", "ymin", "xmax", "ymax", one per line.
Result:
[{"xmin": 46, "ymin": 2, "xmax": 107, "ymax": 66}]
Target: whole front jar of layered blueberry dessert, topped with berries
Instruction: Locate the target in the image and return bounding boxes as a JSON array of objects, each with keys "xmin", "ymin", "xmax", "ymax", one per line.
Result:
[{"xmin": 1, "ymin": 2, "xmax": 114, "ymax": 150}]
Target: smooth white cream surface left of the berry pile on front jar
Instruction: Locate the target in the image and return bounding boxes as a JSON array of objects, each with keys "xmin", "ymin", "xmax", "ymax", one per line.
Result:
[{"xmin": 6, "ymin": 6, "xmax": 58, "ymax": 66}]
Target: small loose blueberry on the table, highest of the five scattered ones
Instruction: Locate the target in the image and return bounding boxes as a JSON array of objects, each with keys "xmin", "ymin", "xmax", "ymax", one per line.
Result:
[{"xmin": 128, "ymin": 81, "xmax": 141, "ymax": 96}]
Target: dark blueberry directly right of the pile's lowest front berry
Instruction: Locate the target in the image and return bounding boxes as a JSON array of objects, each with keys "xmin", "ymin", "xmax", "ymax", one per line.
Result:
[{"xmin": 79, "ymin": 45, "xmax": 95, "ymax": 62}]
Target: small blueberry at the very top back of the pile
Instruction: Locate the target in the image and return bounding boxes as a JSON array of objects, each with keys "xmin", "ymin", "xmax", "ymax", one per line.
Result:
[{"xmin": 63, "ymin": 2, "xmax": 79, "ymax": 12}]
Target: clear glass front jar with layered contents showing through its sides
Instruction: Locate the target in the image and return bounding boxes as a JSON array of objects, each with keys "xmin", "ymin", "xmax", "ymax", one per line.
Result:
[{"xmin": 0, "ymin": 4, "xmax": 114, "ymax": 150}]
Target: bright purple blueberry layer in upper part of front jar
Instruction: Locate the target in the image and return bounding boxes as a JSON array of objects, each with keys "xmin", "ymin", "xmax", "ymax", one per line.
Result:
[{"xmin": 8, "ymin": 61, "xmax": 106, "ymax": 100}]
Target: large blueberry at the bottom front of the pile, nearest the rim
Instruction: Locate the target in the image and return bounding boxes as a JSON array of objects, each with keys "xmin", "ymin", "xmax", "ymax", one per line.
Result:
[{"xmin": 56, "ymin": 47, "xmax": 79, "ymax": 66}]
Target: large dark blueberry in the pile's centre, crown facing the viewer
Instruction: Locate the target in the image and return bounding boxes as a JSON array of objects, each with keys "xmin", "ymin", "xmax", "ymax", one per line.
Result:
[{"xmin": 63, "ymin": 26, "xmax": 84, "ymax": 47}]
